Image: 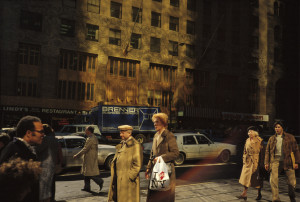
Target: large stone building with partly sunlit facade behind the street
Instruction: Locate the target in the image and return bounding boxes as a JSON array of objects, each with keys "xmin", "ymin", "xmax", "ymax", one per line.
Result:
[{"xmin": 0, "ymin": 0, "xmax": 296, "ymax": 132}]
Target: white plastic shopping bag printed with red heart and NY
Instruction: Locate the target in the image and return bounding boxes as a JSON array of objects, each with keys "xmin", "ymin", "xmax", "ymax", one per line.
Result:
[{"xmin": 149, "ymin": 156, "xmax": 170, "ymax": 191}]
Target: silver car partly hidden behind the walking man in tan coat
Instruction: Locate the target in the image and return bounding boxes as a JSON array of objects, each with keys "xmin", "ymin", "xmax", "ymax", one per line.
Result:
[{"xmin": 56, "ymin": 135, "xmax": 116, "ymax": 170}]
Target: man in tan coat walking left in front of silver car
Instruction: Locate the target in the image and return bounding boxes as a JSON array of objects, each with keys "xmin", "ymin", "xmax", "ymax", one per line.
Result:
[{"xmin": 73, "ymin": 126, "xmax": 104, "ymax": 192}]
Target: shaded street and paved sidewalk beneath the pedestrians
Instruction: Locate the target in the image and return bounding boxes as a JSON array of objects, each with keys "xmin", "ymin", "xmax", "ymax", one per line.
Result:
[{"xmin": 56, "ymin": 161, "xmax": 300, "ymax": 202}]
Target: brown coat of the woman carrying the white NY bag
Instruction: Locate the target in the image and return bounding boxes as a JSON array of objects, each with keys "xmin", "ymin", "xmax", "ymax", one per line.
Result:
[{"xmin": 147, "ymin": 129, "xmax": 179, "ymax": 202}]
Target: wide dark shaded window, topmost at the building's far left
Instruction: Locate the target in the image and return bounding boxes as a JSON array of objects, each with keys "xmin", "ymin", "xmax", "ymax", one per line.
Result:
[{"xmin": 20, "ymin": 11, "xmax": 43, "ymax": 31}]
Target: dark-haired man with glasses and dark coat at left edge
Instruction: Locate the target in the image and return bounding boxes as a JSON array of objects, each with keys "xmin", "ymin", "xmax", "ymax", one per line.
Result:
[{"xmin": 0, "ymin": 116, "xmax": 44, "ymax": 202}]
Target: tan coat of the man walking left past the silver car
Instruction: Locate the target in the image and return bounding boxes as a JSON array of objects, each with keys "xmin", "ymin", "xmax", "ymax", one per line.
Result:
[{"xmin": 75, "ymin": 134, "xmax": 100, "ymax": 176}]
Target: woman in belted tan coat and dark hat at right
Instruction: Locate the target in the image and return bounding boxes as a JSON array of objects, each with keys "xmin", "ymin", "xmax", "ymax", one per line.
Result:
[{"xmin": 237, "ymin": 126, "xmax": 263, "ymax": 200}]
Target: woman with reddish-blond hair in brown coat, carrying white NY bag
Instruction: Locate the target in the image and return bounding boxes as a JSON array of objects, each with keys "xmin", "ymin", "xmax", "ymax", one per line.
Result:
[{"xmin": 145, "ymin": 113, "xmax": 179, "ymax": 202}]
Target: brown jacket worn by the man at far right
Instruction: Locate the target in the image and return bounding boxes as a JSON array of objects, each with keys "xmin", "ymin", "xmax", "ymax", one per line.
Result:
[{"xmin": 265, "ymin": 132, "xmax": 300, "ymax": 170}]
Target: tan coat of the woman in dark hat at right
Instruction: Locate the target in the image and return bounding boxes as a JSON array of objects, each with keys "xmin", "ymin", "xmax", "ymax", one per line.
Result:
[{"xmin": 239, "ymin": 136, "xmax": 263, "ymax": 188}]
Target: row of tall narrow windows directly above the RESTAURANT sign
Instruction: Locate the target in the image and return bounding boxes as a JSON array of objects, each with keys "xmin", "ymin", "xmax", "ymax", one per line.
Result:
[{"xmin": 57, "ymin": 80, "xmax": 94, "ymax": 101}]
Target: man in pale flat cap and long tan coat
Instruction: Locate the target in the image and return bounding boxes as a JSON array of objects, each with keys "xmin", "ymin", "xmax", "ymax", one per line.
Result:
[{"xmin": 108, "ymin": 125, "xmax": 143, "ymax": 202}]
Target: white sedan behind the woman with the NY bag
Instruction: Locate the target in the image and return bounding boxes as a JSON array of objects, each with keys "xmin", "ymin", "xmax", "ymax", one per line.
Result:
[{"xmin": 143, "ymin": 133, "xmax": 236, "ymax": 165}]
